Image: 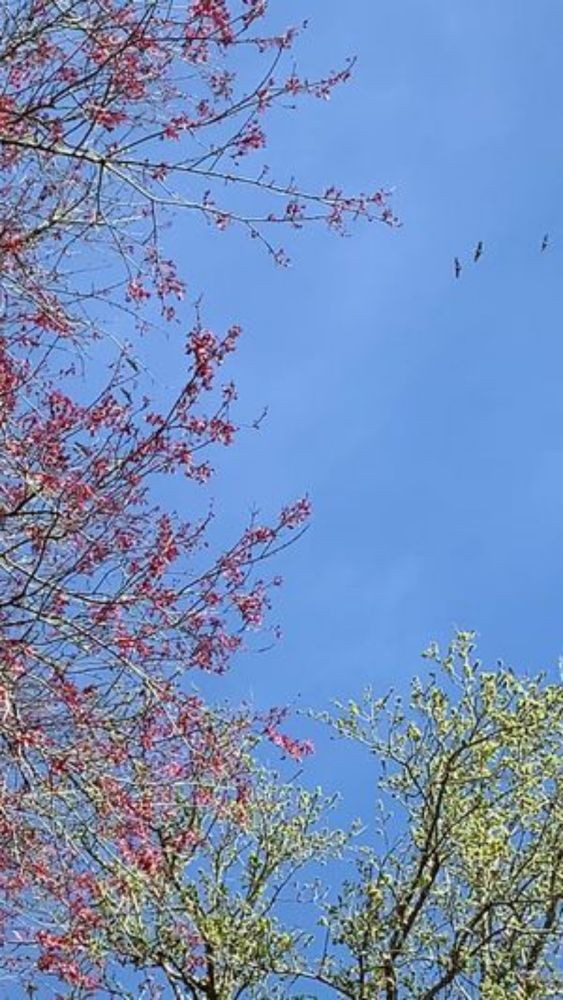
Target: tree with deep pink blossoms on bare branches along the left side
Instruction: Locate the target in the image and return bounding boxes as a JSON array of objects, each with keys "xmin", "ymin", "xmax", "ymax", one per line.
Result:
[{"xmin": 0, "ymin": 0, "xmax": 395, "ymax": 997}]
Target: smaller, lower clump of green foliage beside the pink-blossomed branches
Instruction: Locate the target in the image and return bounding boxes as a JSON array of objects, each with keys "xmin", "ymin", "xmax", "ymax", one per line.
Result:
[{"xmin": 93, "ymin": 768, "xmax": 350, "ymax": 1000}]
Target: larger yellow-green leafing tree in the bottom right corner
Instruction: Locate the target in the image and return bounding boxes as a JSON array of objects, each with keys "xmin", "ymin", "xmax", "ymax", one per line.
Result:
[{"xmin": 316, "ymin": 633, "xmax": 563, "ymax": 1000}]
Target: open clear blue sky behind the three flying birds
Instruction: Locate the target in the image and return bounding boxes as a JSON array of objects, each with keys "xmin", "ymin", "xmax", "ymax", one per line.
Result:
[{"xmin": 151, "ymin": 0, "xmax": 563, "ymax": 804}]
